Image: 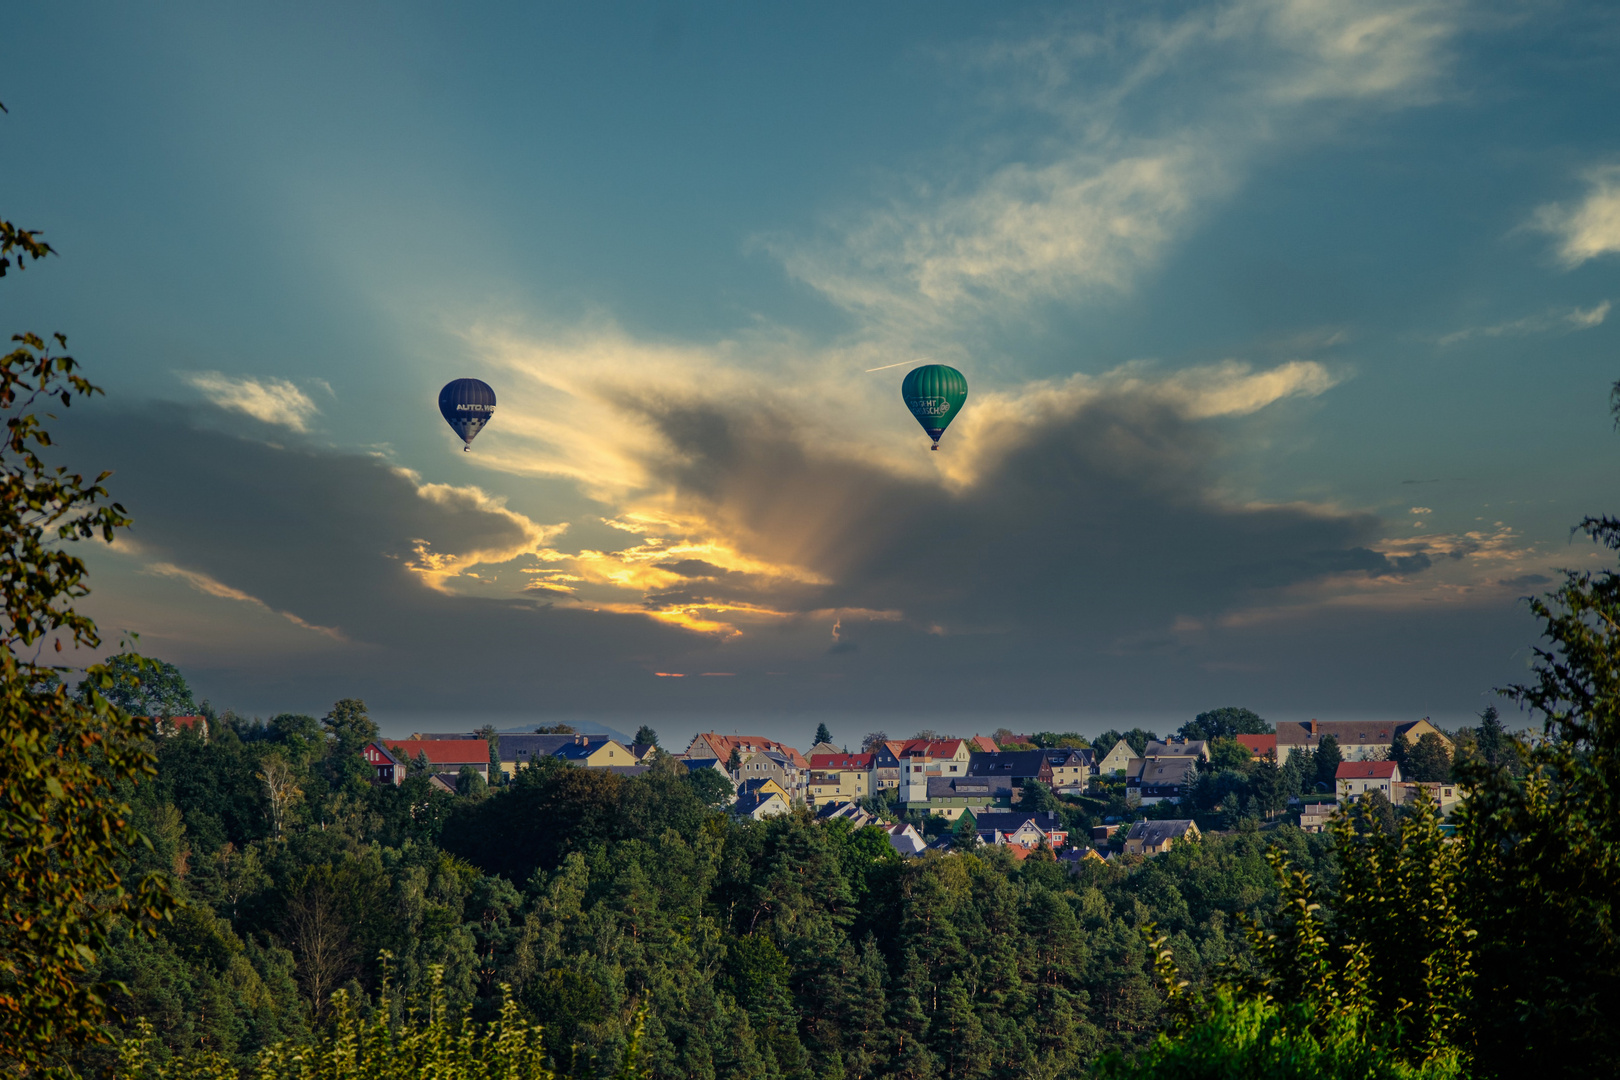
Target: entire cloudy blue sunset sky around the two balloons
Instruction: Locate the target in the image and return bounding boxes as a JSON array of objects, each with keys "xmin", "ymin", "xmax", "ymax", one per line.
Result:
[{"xmin": 0, "ymin": 0, "xmax": 1620, "ymax": 743}]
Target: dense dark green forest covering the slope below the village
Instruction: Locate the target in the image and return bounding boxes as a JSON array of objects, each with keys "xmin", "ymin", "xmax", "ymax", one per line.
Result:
[{"xmin": 92, "ymin": 669, "xmax": 1333, "ymax": 1078}]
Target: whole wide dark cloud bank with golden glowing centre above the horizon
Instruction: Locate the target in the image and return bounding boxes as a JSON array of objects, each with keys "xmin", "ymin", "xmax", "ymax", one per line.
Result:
[{"xmin": 60, "ymin": 375, "xmax": 1537, "ymax": 714}]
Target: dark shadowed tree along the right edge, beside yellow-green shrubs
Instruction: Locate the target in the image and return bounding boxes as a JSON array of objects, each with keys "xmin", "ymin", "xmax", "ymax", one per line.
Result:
[{"xmin": 1458, "ymin": 518, "xmax": 1620, "ymax": 1075}]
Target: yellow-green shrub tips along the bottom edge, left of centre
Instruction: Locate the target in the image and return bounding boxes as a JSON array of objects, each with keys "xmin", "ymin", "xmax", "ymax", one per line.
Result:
[{"xmin": 113, "ymin": 967, "xmax": 646, "ymax": 1080}]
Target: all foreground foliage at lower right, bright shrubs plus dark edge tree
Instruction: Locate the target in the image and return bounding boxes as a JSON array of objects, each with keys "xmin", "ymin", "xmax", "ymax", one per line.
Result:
[{"xmin": 1110, "ymin": 393, "xmax": 1620, "ymax": 1077}]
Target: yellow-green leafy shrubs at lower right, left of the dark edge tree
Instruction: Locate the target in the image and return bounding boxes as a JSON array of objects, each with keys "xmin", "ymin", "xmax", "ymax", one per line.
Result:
[{"xmin": 1102, "ymin": 790, "xmax": 1473, "ymax": 1080}]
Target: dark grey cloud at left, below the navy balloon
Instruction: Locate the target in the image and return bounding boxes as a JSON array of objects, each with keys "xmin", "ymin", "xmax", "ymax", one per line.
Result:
[{"xmin": 55, "ymin": 405, "xmax": 701, "ymax": 711}]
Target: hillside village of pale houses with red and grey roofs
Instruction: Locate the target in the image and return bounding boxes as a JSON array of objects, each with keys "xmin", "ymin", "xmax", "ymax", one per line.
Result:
[{"xmin": 351, "ymin": 717, "xmax": 1463, "ymax": 863}]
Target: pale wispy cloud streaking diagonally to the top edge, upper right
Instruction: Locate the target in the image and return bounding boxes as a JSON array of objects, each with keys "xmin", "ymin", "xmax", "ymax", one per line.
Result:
[{"xmin": 761, "ymin": 0, "xmax": 1456, "ymax": 340}]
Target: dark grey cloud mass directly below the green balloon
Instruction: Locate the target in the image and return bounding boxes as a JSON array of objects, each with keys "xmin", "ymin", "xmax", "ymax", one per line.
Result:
[{"xmin": 618, "ymin": 383, "xmax": 1430, "ymax": 641}]
